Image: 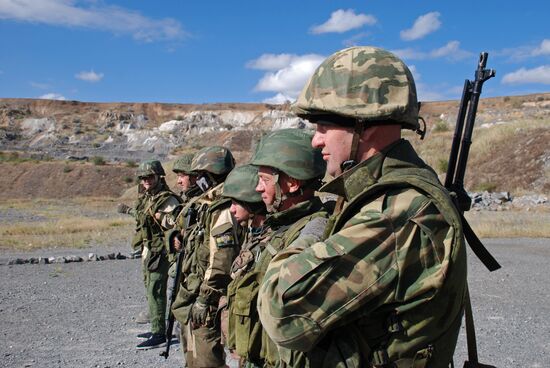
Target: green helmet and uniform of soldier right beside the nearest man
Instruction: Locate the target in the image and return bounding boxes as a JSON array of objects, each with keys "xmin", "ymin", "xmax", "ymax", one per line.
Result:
[{"xmin": 228, "ymin": 129, "xmax": 328, "ymax": 367}]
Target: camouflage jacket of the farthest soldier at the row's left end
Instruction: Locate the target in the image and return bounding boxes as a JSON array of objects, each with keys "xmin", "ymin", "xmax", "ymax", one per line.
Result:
[{"xmin": 134, "ymin": 183, "xmax": 181, "ymax": 253}]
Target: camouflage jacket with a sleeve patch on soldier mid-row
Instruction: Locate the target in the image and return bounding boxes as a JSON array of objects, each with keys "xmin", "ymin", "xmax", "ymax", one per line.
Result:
[{"xmin": 172, "ymin": 184, "xmax": 240, "ymax": 324}]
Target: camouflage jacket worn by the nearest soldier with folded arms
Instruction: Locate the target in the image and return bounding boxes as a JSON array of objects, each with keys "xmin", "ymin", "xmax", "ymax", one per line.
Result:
[{"xmin": 258, "ymin": 140, "xmax": 466, "ymax": 368}]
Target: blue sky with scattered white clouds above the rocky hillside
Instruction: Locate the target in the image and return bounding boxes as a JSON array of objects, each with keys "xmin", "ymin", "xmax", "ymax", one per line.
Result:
[{"xmin": 0, "ymin": 0, "xmax": 550, "ymax": 103}]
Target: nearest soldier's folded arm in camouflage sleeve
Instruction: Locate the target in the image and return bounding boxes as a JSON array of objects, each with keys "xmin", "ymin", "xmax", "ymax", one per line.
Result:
[{"xmin": 258, "ymin": 196, "xmax": 448, "ymax": 351}]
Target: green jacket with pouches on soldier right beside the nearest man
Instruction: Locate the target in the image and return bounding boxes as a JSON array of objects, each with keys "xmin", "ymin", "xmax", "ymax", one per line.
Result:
[{"xmin": 228, "ymin": 197, "xmax": 329, "ymax": 367}]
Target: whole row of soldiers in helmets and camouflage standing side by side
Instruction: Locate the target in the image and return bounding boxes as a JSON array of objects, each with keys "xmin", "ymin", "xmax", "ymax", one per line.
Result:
[{"xmin": 120, "ymin": 47, "xmax": 466, "ymax": 367}]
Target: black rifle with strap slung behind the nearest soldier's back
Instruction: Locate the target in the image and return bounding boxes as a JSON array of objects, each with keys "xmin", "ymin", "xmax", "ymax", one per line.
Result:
[{"xmin": 445, "ymin": 52, "xmax": 501, "ymax": 368}]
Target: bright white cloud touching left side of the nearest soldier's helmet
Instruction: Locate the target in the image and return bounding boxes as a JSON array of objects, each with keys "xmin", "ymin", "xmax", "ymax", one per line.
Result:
[{"xmin": 251, "ymin": 54, "xmax": 325, "ymax": 99}]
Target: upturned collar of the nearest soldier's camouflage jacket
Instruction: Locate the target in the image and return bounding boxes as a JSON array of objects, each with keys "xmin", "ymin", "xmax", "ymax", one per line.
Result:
[{"xmin": 319, "ymin": 139, "xmax": 403, "ymax": 201}]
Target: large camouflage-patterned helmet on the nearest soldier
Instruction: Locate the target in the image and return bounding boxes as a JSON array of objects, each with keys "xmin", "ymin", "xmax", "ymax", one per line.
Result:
[{"xmin": 292, "ymin": 46, "xmax": 420, "ymax": 130}]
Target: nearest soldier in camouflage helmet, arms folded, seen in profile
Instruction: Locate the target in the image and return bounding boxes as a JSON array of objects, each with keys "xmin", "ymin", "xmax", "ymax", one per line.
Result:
[{"xmin": 258, "ymin": 47, "xmax": 466, "ymax": 368}]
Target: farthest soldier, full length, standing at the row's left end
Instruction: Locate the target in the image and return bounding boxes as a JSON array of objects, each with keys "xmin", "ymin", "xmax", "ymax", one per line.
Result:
[{"xmin": 128, "ymin": 160, "xmax": 181, "ymax": 350}]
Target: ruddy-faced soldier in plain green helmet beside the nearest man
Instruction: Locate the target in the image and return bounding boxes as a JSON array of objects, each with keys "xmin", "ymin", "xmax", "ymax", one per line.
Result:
[{"xmin": 228, "ymin": 129, "xmax": 328, "ymax": 368}]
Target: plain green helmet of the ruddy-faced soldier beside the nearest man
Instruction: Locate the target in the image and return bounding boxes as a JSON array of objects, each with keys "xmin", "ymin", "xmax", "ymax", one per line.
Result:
[{"xmin": 251, "ymin": 129, "xmax": 326, "ymax": 180}]
